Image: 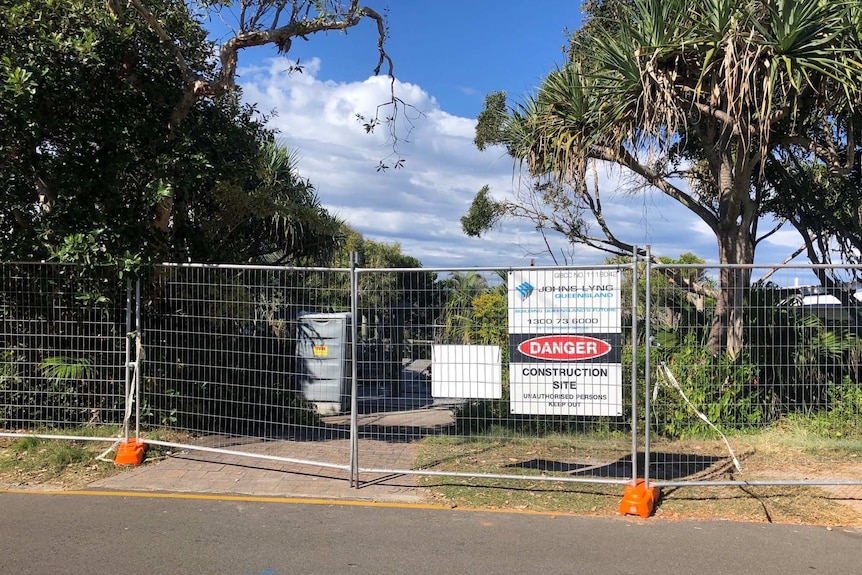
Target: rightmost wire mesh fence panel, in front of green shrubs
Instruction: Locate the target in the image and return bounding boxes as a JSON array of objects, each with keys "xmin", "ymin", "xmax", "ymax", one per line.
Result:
[{"xmin": 645, "ymin": 265, "xmax": 862, "ymax": 484}]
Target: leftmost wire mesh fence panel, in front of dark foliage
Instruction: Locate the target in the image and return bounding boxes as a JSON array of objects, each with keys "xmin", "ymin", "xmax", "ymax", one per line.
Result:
[{"xmin": 0, "ymin": 263, "xmax": 129, "ymax": 432}]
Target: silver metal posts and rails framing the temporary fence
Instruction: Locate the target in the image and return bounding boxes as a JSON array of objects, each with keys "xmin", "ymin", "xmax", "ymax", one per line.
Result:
[{"xmin": 0, "ymin": 260, "xmax": 862, "ymax": 496}]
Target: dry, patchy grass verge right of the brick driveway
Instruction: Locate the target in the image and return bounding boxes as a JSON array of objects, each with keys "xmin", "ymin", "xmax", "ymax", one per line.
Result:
[{"xmin": 417, "ymin": 428, "xmax": 862, "ymax": 526}]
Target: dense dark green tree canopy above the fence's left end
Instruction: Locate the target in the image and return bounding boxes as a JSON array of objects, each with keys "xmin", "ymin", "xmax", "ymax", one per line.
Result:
[{"xmin": 0, "ymin": 0, "xmax": 398, "ymax": 265}]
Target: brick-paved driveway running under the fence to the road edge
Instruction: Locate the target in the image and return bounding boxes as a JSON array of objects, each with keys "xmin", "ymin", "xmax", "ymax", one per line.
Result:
[{"xmin": 90, "ymin": 409, "xmax": 460, "ymax": 503}]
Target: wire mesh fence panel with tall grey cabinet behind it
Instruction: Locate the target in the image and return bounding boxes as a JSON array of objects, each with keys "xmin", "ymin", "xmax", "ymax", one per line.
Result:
[{"xmin": 140, "ymin": 264, "xmax": 350, "ymax": 468}]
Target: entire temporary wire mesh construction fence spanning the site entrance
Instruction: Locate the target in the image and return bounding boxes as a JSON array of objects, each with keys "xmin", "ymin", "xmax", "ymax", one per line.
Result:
[{"xmin": 0, "ymin": 258, "xmax": 862, "ymax": 512}]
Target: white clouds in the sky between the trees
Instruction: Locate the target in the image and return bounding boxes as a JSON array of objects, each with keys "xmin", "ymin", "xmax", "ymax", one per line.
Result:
[{"xmin": 240, "ymin": 58, "xmax": 799, "ymax": 267}]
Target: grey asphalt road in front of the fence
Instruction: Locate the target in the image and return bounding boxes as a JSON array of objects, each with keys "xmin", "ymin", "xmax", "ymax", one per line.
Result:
[{"xmin": 0, "ymin": 491, "xmax": 862, "ymax": 575}]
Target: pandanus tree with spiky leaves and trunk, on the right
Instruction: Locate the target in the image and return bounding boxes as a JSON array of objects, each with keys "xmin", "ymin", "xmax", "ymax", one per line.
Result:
[{"xmin": 466, "ymin": 0, "xmax": 862, "ymax": 355}]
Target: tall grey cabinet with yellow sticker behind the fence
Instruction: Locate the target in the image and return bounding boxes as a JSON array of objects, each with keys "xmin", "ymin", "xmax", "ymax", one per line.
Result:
[{"xmin": 296, "ymin": 313, "xmax": 352, "ymax": 414}]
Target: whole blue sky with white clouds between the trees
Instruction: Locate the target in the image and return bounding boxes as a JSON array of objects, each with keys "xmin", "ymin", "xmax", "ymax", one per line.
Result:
[{"xmin": 204, "ymin": 0, "xmax": 800, "ymax": 267}]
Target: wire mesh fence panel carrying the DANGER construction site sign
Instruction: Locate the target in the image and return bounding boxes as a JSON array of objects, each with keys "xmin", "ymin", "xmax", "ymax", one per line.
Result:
[{"xmin": 356, "ymin": 267, "xmax": 633, "ymax": 483}]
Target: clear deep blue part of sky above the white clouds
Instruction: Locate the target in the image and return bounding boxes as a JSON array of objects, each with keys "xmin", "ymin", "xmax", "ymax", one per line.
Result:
[{"xmin": 209, "ymin": 0, "xmax": 580, "ymax": 117}]
